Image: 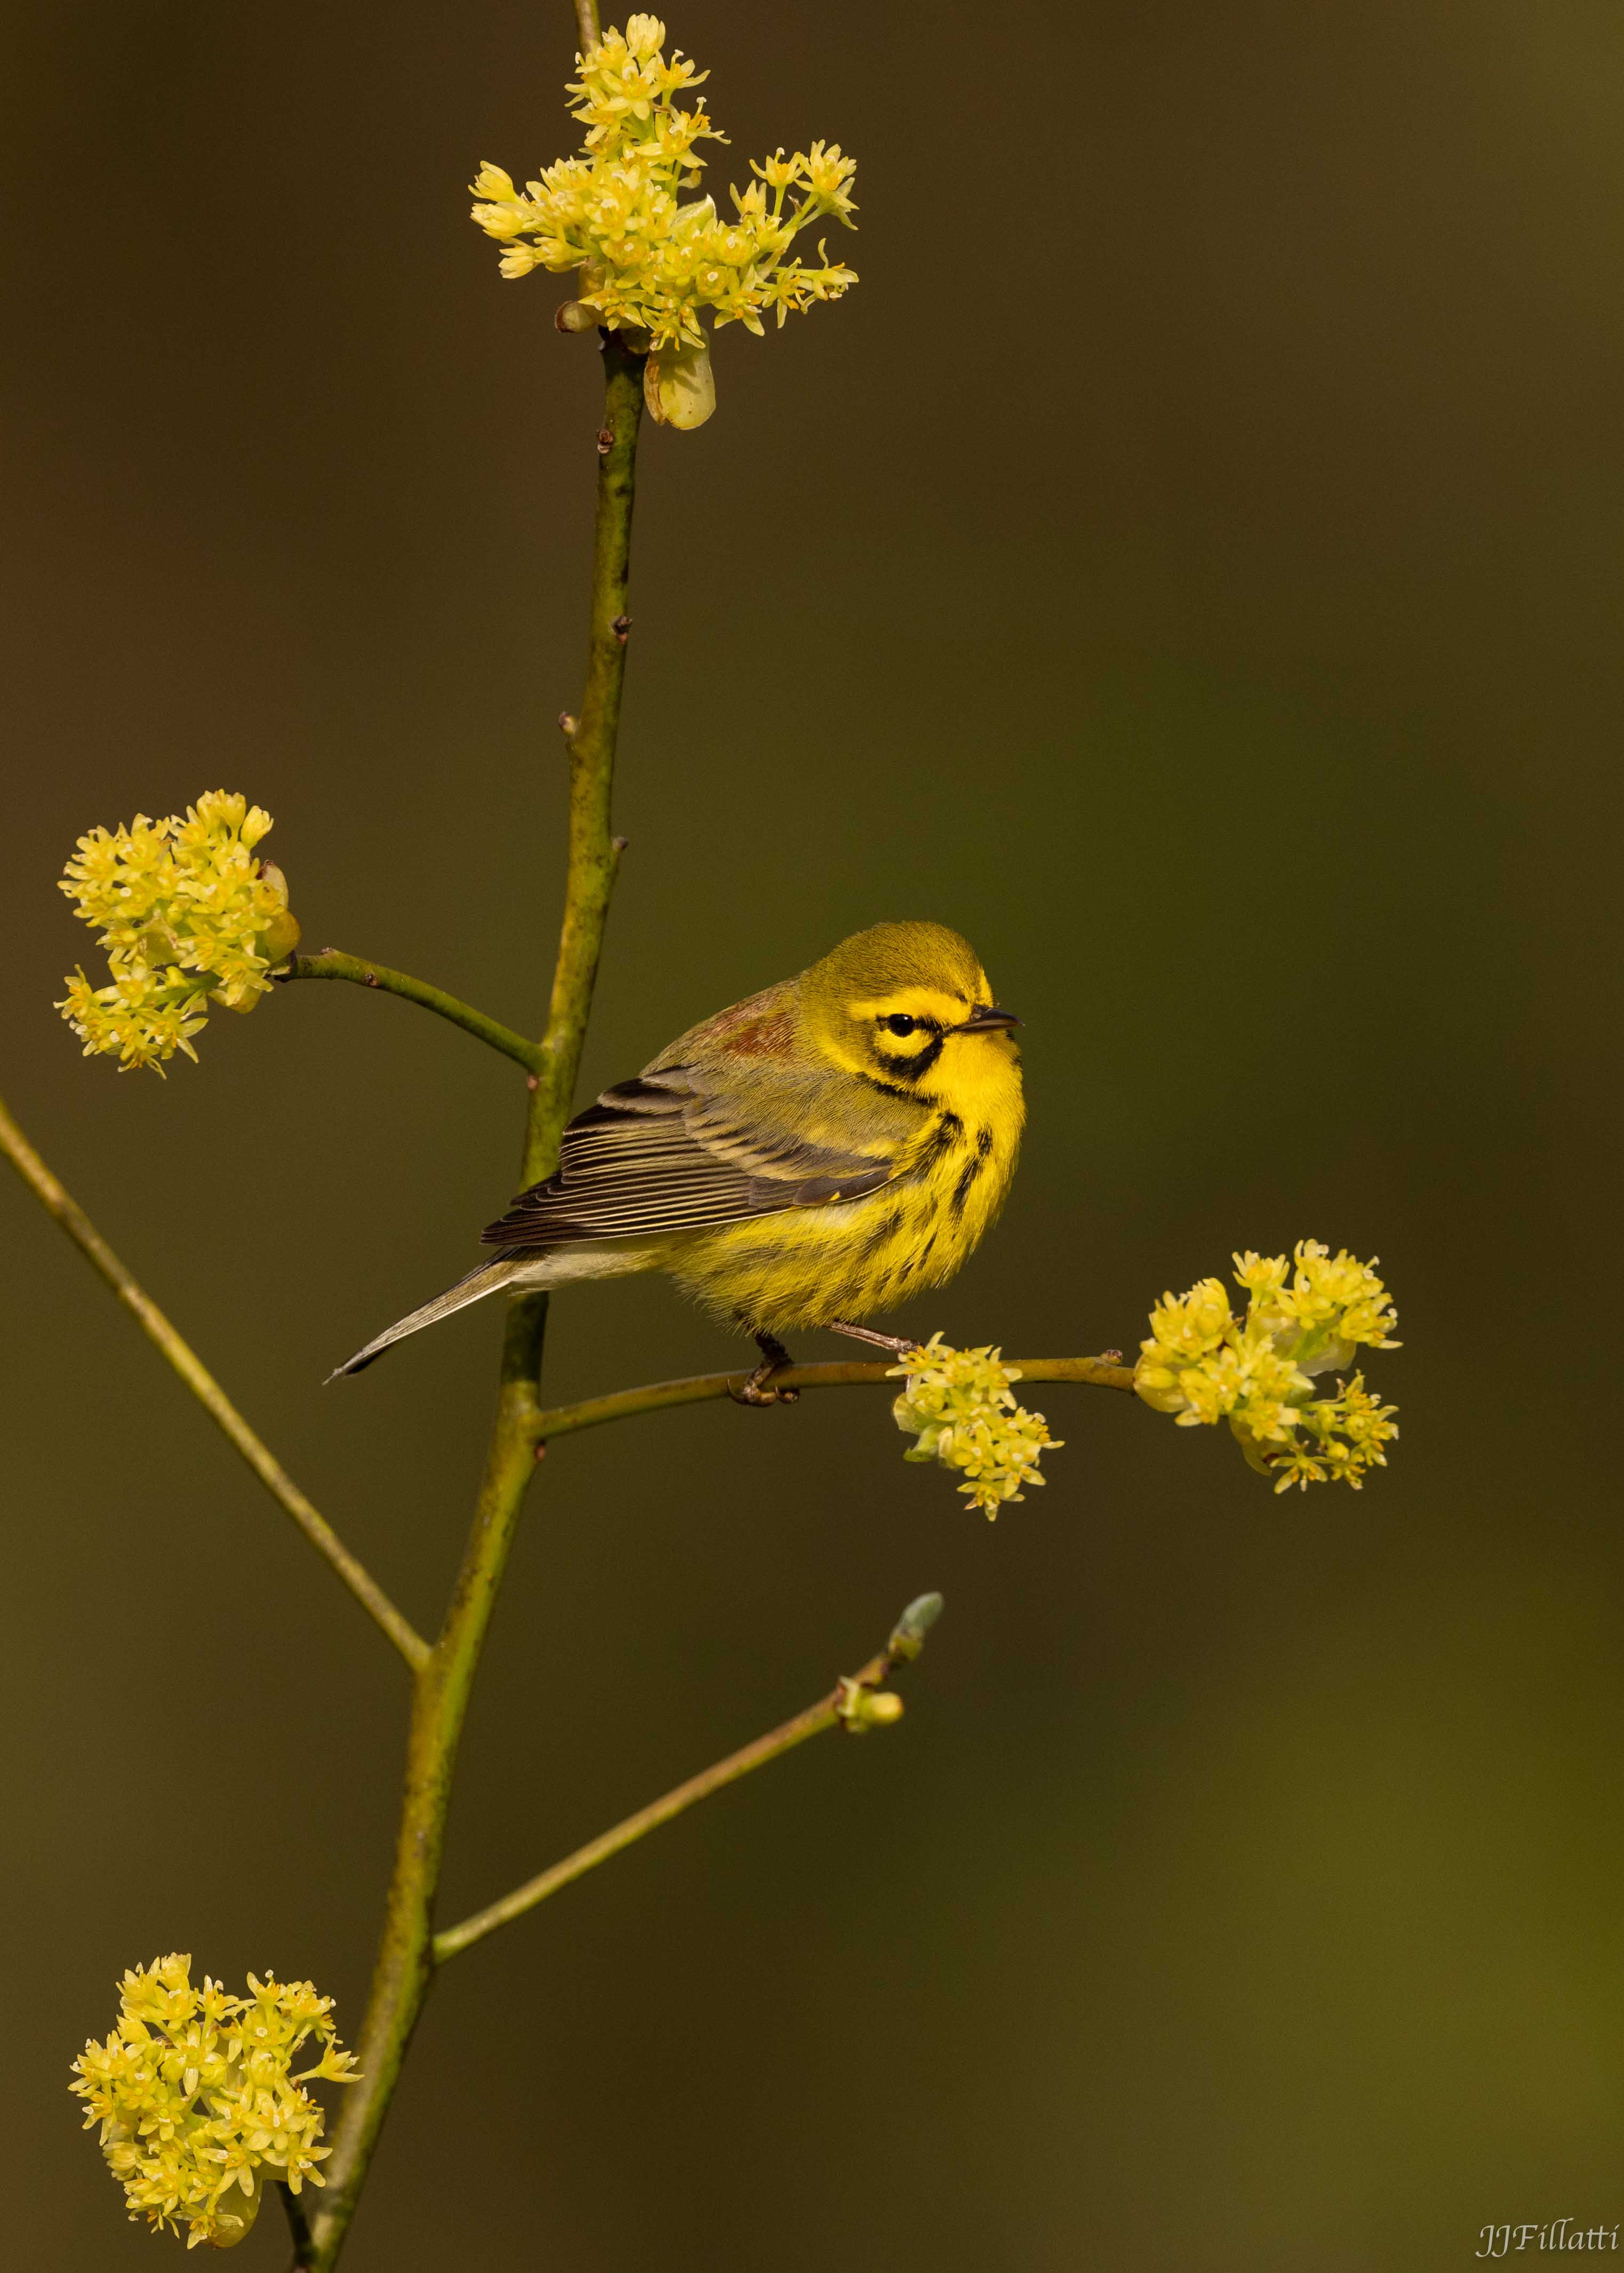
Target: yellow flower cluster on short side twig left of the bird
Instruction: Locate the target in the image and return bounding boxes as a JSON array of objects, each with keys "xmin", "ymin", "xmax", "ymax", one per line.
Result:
[{"xmin": 57, "ymin": 789, "xmax": 298, "ymax": 1073}]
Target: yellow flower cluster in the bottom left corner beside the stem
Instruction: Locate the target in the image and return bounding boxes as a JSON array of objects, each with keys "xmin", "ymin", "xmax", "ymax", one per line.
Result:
[{"xmin": 68, "ymin": 1955, "xmax": 357, "ymax": 2250}]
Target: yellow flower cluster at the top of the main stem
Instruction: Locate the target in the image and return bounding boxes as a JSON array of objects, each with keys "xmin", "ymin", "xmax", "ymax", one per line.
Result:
[{"xmin": 471, "ymin": 16, "xmax": 857, "ymax": 427}]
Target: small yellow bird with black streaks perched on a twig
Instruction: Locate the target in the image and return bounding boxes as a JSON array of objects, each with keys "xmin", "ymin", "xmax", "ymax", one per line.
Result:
[{"xmin": 339, "ymin": 923, "xmax": 1026, "ymax": 1405}]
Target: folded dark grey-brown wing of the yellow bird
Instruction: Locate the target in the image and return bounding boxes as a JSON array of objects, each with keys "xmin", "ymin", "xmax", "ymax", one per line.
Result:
[{"xmin": 482, "ymin": 1062, "xmax": 896, "ymax": 1250}]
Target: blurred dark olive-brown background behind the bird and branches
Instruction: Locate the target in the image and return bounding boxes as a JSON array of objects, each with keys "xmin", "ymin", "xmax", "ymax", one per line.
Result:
[{"xmin": 0, "ymin": 0, "xmax": 1624, "ymax": 2273}]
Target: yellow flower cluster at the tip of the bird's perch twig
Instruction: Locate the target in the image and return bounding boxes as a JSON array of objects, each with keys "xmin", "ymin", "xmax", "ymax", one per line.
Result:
[{"xmin": 1133, "ymin": 1239, "xmax": 1399, "ymax": 1491}]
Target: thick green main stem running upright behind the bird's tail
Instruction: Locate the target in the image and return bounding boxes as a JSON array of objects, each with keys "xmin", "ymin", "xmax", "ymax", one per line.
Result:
[{"xmin": 309, "ymin": 332, "xmax": 644, "ymax": 2273}]
